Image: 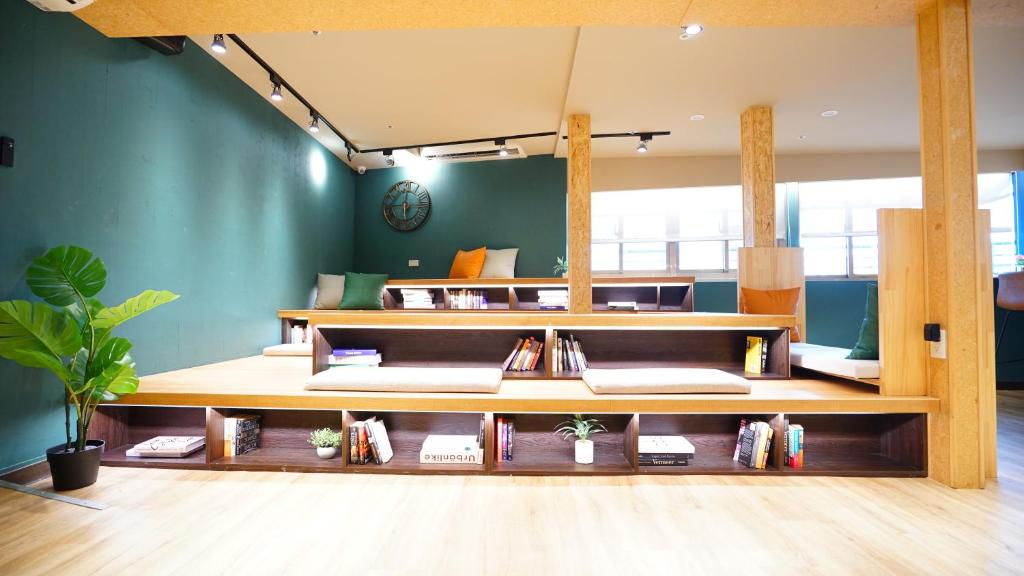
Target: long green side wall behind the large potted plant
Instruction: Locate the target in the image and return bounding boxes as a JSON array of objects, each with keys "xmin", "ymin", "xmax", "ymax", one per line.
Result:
[{"xmin": 0, "ymin": 0, "xmax": 355, "ymax": 471}]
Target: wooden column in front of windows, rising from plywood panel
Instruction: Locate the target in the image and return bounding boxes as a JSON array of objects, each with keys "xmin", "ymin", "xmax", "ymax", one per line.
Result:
[{"xmin": 739, "ymin": 106, "xmax": 775, "ymax": 248}]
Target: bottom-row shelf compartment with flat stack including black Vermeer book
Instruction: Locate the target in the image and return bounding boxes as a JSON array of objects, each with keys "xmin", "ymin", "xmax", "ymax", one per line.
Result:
[{"xmin": 639, "ymin": 414, "xmax": 781, "ymax": 475}]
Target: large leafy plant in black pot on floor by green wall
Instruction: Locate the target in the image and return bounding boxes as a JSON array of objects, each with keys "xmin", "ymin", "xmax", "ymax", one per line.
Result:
[{"xmin": 0, "ymin": 246, "xmax": 178, "ymax": 490}]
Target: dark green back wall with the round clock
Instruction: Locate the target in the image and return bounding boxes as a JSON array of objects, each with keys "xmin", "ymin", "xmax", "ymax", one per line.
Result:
[{"xmin": 356, "ymin": 156, "xmax": 565, "ymax": 278}]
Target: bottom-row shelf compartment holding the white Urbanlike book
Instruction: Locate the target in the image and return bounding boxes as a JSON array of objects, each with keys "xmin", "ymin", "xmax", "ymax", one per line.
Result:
[{"xmin": 342, "ymin": 412, "xmax": 486, "ymax": 474}]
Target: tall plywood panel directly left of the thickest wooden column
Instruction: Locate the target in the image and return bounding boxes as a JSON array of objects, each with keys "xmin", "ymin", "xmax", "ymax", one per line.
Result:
[{"xmin": 879, "ymin": 208, "xmax": 928, "ymax": 396}]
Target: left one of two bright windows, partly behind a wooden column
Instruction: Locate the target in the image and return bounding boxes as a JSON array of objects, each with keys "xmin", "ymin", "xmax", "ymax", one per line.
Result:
[{"xmin": 591, "ymin": 184, "xmax": 785, "ymax": 277}]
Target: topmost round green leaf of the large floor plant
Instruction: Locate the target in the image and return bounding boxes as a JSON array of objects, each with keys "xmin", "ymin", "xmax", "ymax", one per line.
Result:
[{"xmin": 26, "ymin": 246, "xmax": 106, "ymax": 306}]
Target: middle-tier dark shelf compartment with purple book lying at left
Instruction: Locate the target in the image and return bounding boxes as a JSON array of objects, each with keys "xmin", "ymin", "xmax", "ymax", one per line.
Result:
[{"xmin": 313, "ymin": 326, "xmax": 546, "ymax": 378}]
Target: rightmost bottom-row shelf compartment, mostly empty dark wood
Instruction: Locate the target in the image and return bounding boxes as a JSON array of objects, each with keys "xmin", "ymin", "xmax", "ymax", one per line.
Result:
[{"xmin": 783, "ymin": 414, "xmax": 928, "ymax": 477}]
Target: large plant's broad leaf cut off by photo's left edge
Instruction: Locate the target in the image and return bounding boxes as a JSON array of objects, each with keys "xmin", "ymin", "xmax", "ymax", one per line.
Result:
[{"xmin": 0, "ymin": 300, "xmax": 82, "ymax": 382}]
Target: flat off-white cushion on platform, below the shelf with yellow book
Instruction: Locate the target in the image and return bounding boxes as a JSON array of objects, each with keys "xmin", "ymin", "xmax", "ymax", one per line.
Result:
[{"xmin": 583, "ymin": 368, "xmax": 751, "ymax": 394}]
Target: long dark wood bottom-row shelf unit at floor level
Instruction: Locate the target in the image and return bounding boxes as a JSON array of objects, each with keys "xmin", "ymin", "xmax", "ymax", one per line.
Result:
[{"xmin": 93, "ymin": 405, "xmax": 928, "ymax": 478}]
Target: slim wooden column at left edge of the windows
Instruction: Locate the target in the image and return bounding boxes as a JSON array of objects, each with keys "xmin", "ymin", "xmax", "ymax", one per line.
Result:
[{"xmin": 568, "ymin": 114, "xmax": 594, "ymax": 314}]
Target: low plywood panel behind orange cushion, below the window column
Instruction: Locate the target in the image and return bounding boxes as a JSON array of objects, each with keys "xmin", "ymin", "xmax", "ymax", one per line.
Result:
[{"xmin": 736, "ymin": 247, "xmax": 807, "ymax": 341}]
